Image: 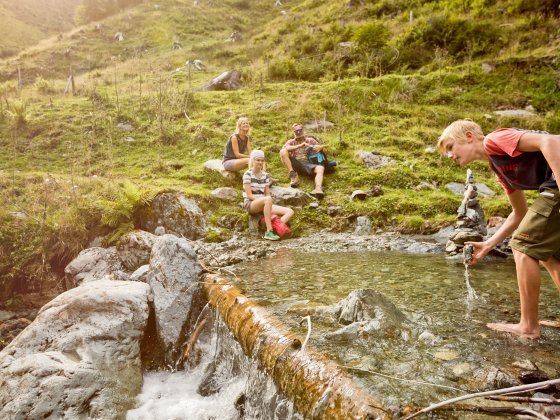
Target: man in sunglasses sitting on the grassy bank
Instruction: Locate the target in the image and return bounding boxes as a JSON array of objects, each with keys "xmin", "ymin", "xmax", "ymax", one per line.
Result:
[{"xmin": 280, "ymin": 123, "xmax": 325, "ymax": 198}]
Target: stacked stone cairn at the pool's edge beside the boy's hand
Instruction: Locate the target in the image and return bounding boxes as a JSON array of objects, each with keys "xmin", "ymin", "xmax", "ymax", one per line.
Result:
[{"xmin": 445, "ymin": 169, "xmax": 487, "ymax": 255}]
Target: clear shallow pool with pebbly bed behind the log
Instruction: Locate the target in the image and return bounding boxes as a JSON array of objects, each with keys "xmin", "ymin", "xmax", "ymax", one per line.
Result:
[{"xmin": 232, "ymin": 250, "xmax": 560, "ymax": 408}]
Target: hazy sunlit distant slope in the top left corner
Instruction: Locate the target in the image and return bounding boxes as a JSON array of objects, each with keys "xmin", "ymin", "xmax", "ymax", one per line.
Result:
[{"xmin": 0, "ymin": 0, "xmax": 82, "ymax": 58}]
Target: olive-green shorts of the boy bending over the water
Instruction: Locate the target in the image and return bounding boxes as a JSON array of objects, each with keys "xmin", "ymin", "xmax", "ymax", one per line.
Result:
[{"xmin": 510, "ymin": 188, "xmax": 560, "ymax": 261}]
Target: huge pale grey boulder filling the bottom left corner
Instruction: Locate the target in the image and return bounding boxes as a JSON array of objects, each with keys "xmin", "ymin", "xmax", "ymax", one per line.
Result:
[{"xmin": 0, "ymin": 280, "xmax": 150, "ymax": 419}]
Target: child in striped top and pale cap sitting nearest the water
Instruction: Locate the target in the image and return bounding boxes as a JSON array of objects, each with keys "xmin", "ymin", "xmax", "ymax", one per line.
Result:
[{"xmin": 243, "ymin": 150, "xmax": 294, "ymax": 241}]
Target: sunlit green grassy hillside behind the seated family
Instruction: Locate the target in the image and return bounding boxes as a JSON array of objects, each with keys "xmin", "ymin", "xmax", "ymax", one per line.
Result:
[{"xmin": 0, "ymin": 0, "xmax": 560, "ymax": 298}]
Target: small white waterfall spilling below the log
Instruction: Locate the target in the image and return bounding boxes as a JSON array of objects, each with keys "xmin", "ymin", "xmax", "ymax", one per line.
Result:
[{"xmin": 126, "ymin": 314, "xmax": 302, "ymax": 420}]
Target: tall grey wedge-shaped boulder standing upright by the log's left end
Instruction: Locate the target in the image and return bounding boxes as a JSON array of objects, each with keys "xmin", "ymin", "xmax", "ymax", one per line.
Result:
[{"xmin": 146, "ymin": 235, "xmax": 200, "ymax": 364}]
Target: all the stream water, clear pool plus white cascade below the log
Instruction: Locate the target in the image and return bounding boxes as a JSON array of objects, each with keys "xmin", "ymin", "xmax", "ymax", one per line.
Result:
[{"xmin": 127, "ymin": 249, "xmax": 560, "ymax": 420}]
